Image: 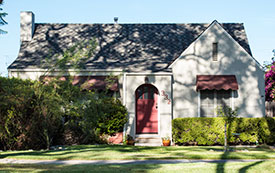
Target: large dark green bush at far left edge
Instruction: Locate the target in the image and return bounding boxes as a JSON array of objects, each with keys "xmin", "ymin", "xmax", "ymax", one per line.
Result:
[{"xmin": 0, "ymin": 77, "xmax": 61, "ymax": 150}]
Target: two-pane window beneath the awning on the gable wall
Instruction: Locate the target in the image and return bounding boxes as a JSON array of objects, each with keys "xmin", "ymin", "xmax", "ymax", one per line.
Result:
[{"xmin": 200, "ymin": 90, "xmax": 232, "ymax": 117}]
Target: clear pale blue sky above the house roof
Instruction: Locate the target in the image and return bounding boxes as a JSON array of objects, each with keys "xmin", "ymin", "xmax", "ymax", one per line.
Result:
[{"xmin": 0, "ymin": 0, "xmax": 275, "ymax": 76}]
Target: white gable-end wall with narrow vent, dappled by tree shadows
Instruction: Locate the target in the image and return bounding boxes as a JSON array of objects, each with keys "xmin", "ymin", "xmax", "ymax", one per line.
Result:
[{"xmin": 171, "ymin": 23, "xmax": 265, "ymax": 118}]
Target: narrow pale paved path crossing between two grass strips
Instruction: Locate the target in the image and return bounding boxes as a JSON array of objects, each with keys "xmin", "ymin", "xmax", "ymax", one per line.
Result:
[{"xmin": 0, "ymin": 159, "xmax": 274, "ymax": 165}]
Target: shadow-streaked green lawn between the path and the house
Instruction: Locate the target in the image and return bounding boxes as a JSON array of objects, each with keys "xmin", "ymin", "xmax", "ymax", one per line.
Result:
[{"xmin": 0, "ymin": 145, "xmax": 275, "ymax": 160}]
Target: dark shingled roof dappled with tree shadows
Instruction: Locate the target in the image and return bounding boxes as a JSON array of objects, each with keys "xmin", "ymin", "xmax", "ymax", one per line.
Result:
[{"xmin": 8, "ymin": 23, "xmax": 252, "ymax": 72}]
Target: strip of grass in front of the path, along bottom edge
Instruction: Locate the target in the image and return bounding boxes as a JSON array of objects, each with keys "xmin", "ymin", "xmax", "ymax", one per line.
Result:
[{"xmin": 0, "ymin": 161, "xmax": 275, "ymax": 173}]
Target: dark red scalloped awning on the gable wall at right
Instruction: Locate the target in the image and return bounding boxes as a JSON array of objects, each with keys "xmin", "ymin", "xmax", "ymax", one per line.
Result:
[{"xmin": 196, "ymin": 75, "xmax": 239, "ymax": 91}]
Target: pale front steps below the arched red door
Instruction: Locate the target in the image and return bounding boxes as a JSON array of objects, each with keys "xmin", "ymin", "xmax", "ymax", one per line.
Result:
[{"xmin": 135, "ymin": 136, "xmax": 162, "ymax": 146}]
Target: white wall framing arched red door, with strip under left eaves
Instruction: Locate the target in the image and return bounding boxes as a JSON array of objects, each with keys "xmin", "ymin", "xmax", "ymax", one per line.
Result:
[{"xmin": 9, "ymin": 69, "xmax": 175, "ymax": 138}]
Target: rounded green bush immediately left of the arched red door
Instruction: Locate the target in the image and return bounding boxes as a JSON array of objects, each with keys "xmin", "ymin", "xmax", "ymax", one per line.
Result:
[{"xmin": 78, "ymin": 93, "xmax": 127, "ymax": 144}]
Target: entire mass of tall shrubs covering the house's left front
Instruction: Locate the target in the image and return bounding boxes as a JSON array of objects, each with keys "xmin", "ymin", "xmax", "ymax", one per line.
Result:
[{"xmin": 0, "ymin": 77, "xmax": 127, "ymax": 150}]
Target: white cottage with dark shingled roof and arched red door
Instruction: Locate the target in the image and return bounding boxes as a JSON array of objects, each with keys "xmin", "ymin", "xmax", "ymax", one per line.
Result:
[{"xmin": 8, "ymin": 12, "xmax": 265, "ymax": 143}]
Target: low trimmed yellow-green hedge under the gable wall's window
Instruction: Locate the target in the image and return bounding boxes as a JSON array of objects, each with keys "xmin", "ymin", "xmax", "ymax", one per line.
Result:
[{"xmin": 172, "ymin": 117, "xmax": 275, "ymax": 145}]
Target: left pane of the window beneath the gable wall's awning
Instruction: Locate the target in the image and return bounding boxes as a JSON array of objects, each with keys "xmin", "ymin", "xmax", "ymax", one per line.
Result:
[{"xmin": 200, "ymin": 90, "xmax": 214, "ymax": 117}]
